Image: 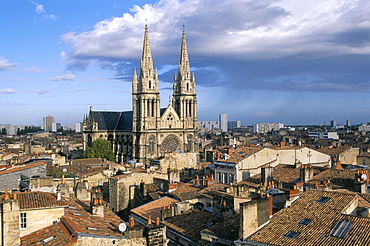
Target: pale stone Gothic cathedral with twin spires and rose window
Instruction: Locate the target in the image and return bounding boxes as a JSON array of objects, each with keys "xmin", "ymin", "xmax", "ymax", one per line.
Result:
[{"xmin": 83, "ymin": 25, "xmax": 199, "ymax": 164}]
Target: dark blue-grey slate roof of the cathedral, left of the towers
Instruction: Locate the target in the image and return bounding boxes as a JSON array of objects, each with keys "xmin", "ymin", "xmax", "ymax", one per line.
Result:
[{"xmin": 92, "ymin": 111, "xmax": 132, "ymax": 131}]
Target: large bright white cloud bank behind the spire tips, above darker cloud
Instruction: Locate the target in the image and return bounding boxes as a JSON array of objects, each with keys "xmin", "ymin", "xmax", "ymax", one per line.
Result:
[{"xmin": 62, "ymin": 0, "xmax": 370, "ymax": 65}]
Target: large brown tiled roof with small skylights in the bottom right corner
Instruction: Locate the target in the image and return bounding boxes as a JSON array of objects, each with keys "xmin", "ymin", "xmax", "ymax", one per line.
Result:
[{"xmin": 248, "ymin": 191, "xmax": 370, "ymax": 246}]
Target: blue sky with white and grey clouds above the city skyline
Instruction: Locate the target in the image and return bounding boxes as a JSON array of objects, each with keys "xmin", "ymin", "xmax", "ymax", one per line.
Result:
[{"xmin": 0, "ymin": 0, "xmax": 370, "ymax": 125}]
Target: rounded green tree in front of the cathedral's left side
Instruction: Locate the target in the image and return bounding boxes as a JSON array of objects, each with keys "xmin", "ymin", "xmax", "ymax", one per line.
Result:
[{"xmin": 84, "ymin": 139, "xmax": 115, "ymax": 161}]
